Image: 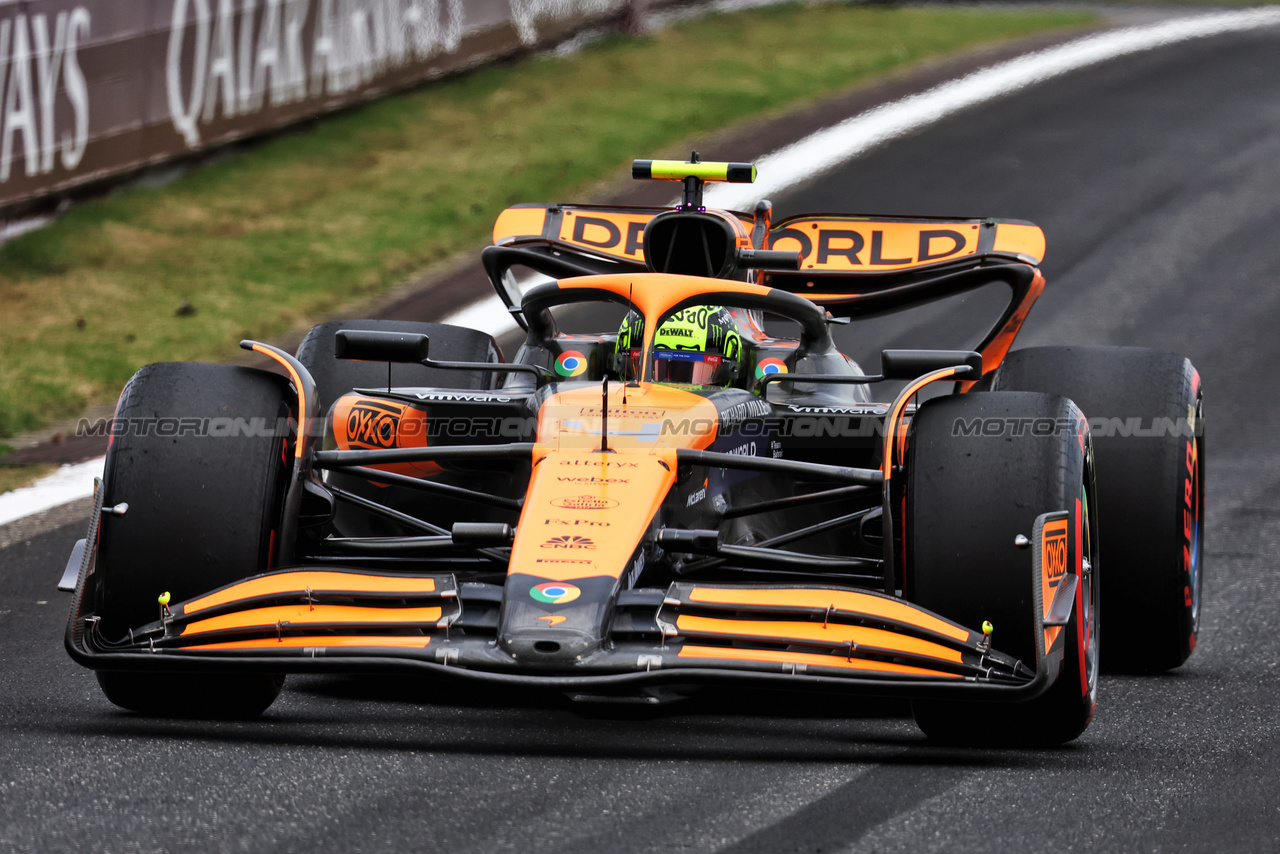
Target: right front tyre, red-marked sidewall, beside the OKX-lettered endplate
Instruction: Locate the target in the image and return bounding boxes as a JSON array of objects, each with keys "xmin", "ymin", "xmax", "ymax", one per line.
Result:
[{"xmin": 905, "ymin": 392, "xmax": 1100, "ymax": 745}]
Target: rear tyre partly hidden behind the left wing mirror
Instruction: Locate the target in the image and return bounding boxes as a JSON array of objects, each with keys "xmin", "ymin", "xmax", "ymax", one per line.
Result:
[{"xmin": 298, "ymin": 320, "xmax": 502, "ymax": 411}]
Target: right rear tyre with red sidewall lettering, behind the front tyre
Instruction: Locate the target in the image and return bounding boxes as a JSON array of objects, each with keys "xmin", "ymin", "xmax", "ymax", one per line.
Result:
[{"xmin": 992, "ymin": 347, "xmax": 1204, "ymax": 672}]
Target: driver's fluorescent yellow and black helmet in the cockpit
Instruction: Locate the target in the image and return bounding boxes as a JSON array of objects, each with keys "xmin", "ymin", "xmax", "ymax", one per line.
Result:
[{"xmin": 616, "ymin": 306, "xmax": 744, "ymax": 385}]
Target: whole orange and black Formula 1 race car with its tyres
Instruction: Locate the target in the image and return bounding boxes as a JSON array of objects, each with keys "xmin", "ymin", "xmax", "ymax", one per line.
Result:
[{"xmin": 63, "ymin": 152, "xmax": 1204, "ymax": 744}]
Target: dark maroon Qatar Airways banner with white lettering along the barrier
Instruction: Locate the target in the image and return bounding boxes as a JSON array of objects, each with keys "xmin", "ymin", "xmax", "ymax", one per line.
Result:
[{"xmin": 0, "ymin": 0, "xmax": 626, "ymax": 210}]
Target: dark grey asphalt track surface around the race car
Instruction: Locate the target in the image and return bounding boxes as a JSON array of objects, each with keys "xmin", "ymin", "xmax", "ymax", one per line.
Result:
[{"xmin": 0, "ymin": 20, "xmax": 1280, "ymax": 853}]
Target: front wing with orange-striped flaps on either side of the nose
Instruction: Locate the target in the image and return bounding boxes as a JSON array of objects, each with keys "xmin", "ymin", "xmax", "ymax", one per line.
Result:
[{"xmin": 65, "ymin": 515, "xmax": 1070, "ymax": 700}]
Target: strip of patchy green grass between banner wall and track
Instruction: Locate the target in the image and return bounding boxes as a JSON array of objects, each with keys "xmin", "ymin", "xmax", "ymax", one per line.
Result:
[{"xmin": 0, "ymin": 5, "xmax": 1092, "ymax": 437}]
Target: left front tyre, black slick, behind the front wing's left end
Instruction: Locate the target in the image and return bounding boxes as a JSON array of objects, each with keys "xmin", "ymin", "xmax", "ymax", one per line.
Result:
[{"xmin": 92, "ymin": 362, "xmax": 291, "ymax": 717}]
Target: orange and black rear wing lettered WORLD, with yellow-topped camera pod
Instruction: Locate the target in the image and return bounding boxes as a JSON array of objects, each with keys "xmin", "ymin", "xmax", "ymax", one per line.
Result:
[{"xmin": 481, "ymin": 151, "xmax": 1044, "ymax": 371}]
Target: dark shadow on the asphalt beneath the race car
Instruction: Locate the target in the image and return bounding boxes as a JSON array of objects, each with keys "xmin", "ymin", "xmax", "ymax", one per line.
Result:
[{"xmin": 40, "ymin": 676, "xmax": 1088, "ymax": 768}]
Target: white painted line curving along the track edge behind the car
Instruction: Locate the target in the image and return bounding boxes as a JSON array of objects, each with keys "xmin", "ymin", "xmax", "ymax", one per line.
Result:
[{"xmin": 0, "ymin": 8, "xmax": 1280, "ymax": 525}]
